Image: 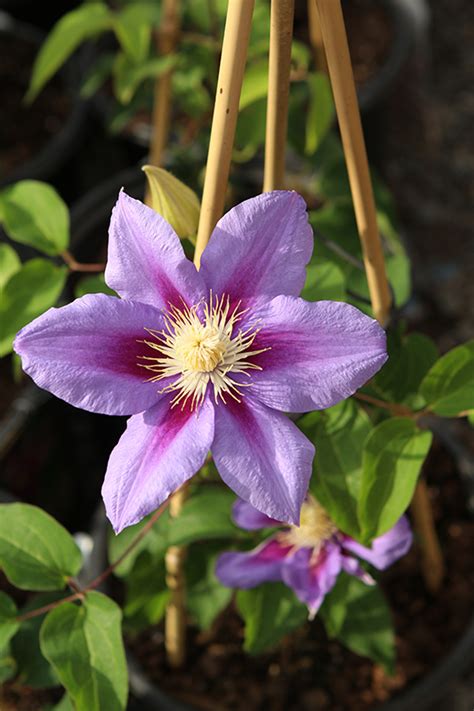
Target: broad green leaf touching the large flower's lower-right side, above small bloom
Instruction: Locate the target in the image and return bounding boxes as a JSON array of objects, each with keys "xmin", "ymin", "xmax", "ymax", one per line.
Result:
[{"xmin": 298, "ymin": 400, "xmax": 372, "ymax": 538}]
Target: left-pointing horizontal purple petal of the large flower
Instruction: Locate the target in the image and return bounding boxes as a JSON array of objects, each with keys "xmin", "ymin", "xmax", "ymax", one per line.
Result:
[{"xmin": 14, "ymin": 294, "xmax": 163, "ymax": 415}]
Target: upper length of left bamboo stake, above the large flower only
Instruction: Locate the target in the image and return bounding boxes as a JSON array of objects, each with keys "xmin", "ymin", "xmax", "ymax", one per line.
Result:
[{"xmin": 194, "ymin": 0, "xmax": 254, "ymax": 268}]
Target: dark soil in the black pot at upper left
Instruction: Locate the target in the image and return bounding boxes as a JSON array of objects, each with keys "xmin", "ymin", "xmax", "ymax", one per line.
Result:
[{"xmin": 0, "ymin": 31, "xmax": 71, "ymax": 180}]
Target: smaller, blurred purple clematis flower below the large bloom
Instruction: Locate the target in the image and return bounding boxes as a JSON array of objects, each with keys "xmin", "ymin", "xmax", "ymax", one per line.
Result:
[{"xmin": 216, "ymin": 496, "xmax": 412, "ymax": 619}]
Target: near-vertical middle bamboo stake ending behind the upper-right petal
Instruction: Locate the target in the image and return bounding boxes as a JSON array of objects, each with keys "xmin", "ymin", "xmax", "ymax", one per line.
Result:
[{"xmin": 263, "ymin": 0, "xmax": 295, "ymax": 192}]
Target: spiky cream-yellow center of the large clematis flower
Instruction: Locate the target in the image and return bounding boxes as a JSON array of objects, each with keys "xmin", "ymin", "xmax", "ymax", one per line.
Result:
[{"xmin": 139, "ymin": 293, "xmax": 268, "ymax": 409}]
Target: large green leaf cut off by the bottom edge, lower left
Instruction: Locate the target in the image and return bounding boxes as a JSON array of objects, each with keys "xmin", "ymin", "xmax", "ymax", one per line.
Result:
[{"xmin": 40, "ymin": 592, "xmax": 128, "ymax": 711}]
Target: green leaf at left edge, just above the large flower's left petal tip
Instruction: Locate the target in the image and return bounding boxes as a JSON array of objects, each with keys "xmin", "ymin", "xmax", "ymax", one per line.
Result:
[{"xmin": 0, "ymin": 259, "xmax": 68, "ymax": 356}]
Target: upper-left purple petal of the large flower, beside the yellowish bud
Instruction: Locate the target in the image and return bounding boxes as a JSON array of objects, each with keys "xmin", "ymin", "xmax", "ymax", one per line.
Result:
[{"xmin": 105, "ymin": 190, "xmax": 206, "ymax": 309}]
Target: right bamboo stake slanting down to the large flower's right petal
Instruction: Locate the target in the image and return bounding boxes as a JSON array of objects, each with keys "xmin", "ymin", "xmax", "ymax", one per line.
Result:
[{"xmin": 314, "ymin": 0, "xmax": 391, "ymax": 326}]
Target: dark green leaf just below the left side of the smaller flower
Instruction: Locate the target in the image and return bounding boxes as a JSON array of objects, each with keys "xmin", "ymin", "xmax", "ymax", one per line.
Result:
[{"xmin": 237, "ymin": 583, "xmax": 308, "ymax": 654}]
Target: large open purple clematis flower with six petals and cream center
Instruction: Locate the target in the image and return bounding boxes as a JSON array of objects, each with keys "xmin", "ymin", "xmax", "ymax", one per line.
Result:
[{"xmin": 14, "ymin": 191, "xmax": 387, "ymax": 531}]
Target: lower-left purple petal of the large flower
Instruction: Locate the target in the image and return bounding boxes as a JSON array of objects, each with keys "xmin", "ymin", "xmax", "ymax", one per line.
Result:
[{"xmin": 102, "ymin": 396, "xmax": 214, "ymax": 533}]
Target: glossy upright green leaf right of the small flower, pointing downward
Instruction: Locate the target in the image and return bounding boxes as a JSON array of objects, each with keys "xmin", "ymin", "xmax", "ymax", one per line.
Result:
[{"xmin": 359, "ymin": 417, "xmax": 433, "ymax": 543}]
